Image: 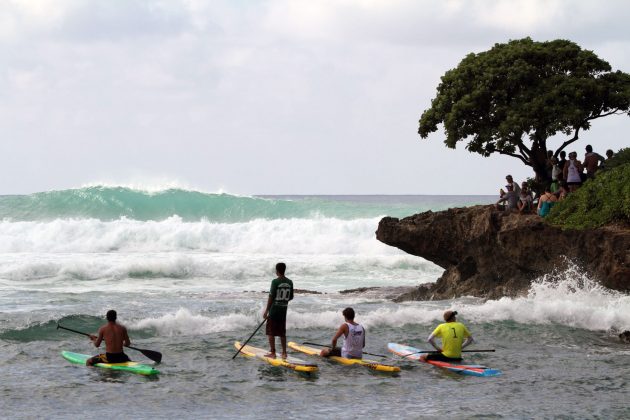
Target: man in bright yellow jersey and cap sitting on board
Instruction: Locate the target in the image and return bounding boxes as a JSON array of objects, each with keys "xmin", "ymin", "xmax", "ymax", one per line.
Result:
[{"xmin": 421, "ymin": 311, "xmax": 474, "ymax": 362}]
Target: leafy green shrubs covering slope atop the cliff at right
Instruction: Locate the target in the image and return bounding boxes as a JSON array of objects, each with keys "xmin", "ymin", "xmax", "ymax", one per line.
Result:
[{"xmin": 546, "ymin": 148, "xmax": 630, "ymax": 229}]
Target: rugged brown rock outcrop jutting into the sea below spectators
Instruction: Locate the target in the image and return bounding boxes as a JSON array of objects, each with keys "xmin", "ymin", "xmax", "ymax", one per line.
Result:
[{"xmin": 376, "ymin": 206, "xmax": 630, "ymax": 300}]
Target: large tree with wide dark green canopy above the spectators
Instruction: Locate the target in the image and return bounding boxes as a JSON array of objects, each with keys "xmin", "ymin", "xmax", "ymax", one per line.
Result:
[{"xmin": 418, "ymin": 38, "xmax": 630, "ymax": 181}]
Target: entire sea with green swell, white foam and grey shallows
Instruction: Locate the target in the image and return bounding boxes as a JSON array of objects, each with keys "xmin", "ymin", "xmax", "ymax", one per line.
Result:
[{"xmin": 0, "ymin": 186, "xmax": 630, "ymax": 418}]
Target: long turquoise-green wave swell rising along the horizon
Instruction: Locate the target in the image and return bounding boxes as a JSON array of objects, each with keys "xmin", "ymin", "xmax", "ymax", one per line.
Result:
[{"xmin": 0, "ymin": 186, "xmax": 470, "ymax": 223}]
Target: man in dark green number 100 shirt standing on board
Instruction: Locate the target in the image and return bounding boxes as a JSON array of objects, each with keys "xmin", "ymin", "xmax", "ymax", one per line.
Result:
[{"xmin": 263, "ymin": 263, "xmax": 293, "ymax": 359}]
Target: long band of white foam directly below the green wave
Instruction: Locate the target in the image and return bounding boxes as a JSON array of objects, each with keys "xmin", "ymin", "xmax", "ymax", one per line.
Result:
[{"xmin": 0, "ymin": 216, "xmax": 400, "ymax": 255}]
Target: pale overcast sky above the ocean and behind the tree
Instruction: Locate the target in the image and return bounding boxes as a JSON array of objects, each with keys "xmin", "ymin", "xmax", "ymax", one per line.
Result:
[{"xmin": 0, "ymin": 0, "xmax": 630, "ymax": 195}]
